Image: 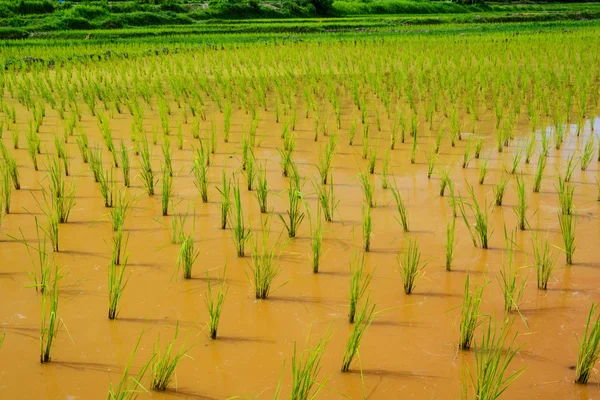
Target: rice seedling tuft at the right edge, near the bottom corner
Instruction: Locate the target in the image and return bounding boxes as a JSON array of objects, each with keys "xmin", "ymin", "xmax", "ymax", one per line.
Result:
[{"xmin": 575, "ymin": 304, "xmax": 600, "ymax": 384}]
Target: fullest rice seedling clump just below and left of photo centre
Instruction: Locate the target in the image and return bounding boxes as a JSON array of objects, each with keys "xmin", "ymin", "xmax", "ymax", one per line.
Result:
[{"xmin": 250, "ymin": 217, "xmax": 283, "ymax": 300}]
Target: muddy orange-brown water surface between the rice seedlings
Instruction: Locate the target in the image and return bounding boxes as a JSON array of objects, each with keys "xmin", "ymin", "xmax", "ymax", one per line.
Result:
[{"xmin": 0, "ymin": 93, "xmax": 600, "ymax": 399}]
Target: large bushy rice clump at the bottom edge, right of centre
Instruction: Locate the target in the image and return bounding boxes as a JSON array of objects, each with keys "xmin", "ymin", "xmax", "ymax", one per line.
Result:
[{"xmin": 463, "ymin": 318, "xmax": 524, "ymax": 400}]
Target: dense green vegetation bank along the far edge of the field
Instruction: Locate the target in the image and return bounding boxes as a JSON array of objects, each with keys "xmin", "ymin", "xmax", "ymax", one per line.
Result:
[{"xmin": 0, "ymin": 0, "xmax": 600, "ymax": 39}]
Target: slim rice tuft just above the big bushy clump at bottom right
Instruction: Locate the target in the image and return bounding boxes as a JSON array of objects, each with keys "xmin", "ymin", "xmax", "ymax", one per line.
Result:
[{"xmin": 499, "ymin": 226, "xmax": 526, "ymax": 313}]
